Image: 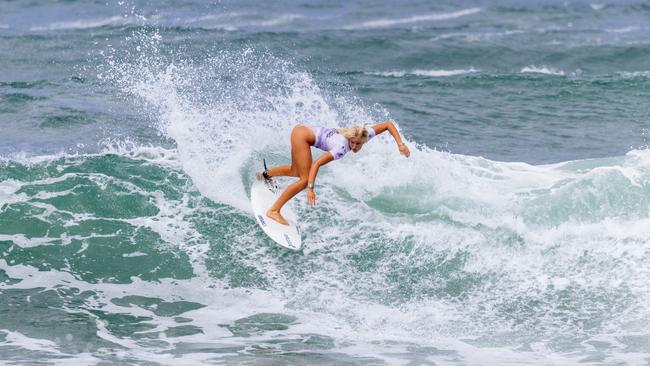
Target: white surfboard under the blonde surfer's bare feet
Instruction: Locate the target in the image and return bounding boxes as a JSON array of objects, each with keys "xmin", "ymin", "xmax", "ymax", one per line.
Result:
[{"xmin": 251, "ymin": 179, "xmax": 302, "ymax": 250}]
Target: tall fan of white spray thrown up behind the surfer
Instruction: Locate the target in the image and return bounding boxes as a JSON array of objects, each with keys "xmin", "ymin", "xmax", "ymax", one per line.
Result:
[{"xmin": 99, "ymin": 31, "xmax": 384, "ymax": 210}]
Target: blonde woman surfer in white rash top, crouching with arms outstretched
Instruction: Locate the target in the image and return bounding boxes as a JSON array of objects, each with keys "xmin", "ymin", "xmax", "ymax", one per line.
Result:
[{"xmin": 258, "ymin": 121, "xmax": 411, "ymax": 225}]
